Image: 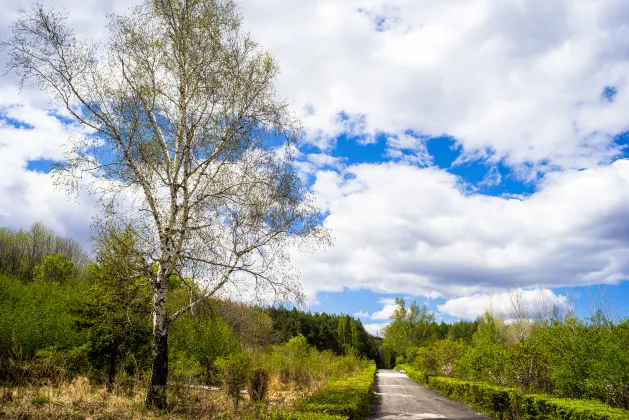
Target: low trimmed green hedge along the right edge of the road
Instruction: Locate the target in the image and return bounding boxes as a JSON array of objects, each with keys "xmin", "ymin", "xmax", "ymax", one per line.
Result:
[{"xmin": 396, "ymin": 365, "xmax": 629, "ymax": 420}]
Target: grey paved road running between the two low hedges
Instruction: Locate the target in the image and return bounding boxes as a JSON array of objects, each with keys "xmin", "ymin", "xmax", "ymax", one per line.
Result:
[{"xmin": 369, "ymin": 369, "xmax": 487, "ymax": 420}]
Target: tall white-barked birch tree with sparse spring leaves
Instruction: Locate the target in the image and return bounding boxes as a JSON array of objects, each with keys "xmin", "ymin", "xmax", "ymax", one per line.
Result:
[{"xmin": 3, "ymin": 0, "xmax": 328, "ymax": 408}]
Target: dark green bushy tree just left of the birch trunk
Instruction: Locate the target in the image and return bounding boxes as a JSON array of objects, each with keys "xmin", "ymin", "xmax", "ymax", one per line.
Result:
[{"xmin": 72, "ymin": 230, "xmax": 151, "ymax": 390}]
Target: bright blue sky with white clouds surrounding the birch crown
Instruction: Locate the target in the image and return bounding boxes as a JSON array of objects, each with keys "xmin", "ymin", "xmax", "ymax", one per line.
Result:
[{"xmin": 0, "ymin": 0, "xmax": 629, "ymax": 333}]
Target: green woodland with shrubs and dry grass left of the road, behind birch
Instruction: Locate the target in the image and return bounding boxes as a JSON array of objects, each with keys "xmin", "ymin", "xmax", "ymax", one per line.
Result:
[{"xmin": 0, "ymin": 224, "xmax": 379, "ymax": 419}]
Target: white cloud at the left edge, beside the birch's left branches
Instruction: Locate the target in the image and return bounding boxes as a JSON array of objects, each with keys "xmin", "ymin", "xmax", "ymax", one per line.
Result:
[{"xmin": 0, "ymin": 104, "xmax": 95, "ymax": 242}]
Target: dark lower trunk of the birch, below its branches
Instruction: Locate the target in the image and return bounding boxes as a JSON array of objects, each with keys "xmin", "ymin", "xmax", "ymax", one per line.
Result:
[{"xmin": 145, "ymin": 281, "xmax": 168, "ymax": 410}]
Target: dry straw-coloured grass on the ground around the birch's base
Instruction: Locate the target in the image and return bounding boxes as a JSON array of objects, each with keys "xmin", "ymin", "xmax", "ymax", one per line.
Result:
[{"xmin": 0, "ymin": 377, "xmax": 322, "ymax": 420}]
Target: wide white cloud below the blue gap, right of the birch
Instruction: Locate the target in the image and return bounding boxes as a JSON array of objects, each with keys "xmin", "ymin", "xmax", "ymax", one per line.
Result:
[{"xmin": 295, "ymin": 160, "xmax": 629, "ymax": 298}]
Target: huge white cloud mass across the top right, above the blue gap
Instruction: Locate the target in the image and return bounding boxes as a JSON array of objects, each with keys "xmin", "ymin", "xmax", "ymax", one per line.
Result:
[{"xmin": 241, "ymin": 0, "xmax": 629, "ymax": 177}]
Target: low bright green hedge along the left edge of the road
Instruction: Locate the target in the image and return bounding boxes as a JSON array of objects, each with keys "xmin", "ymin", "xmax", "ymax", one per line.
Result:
[{"xmin": 299, "ymin": 364, "xmax": 376, "ymax": 420}]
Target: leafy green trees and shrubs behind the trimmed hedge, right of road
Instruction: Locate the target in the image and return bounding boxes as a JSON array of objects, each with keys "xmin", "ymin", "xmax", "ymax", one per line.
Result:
[{"xmin": 384, "ymin": 300, "xmax": 629, "ymax": 409}]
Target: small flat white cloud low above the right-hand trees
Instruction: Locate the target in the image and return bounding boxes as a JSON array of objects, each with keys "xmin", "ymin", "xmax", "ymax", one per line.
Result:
[{"xmin": 437, "ymin": 289, "xmax": 568, "ymax": 319}]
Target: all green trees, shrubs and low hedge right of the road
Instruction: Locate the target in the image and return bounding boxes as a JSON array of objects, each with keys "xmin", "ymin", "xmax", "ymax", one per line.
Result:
[{"xmin": 384, "ymin": 296, "xmax": 629, "ymax": 419}]
